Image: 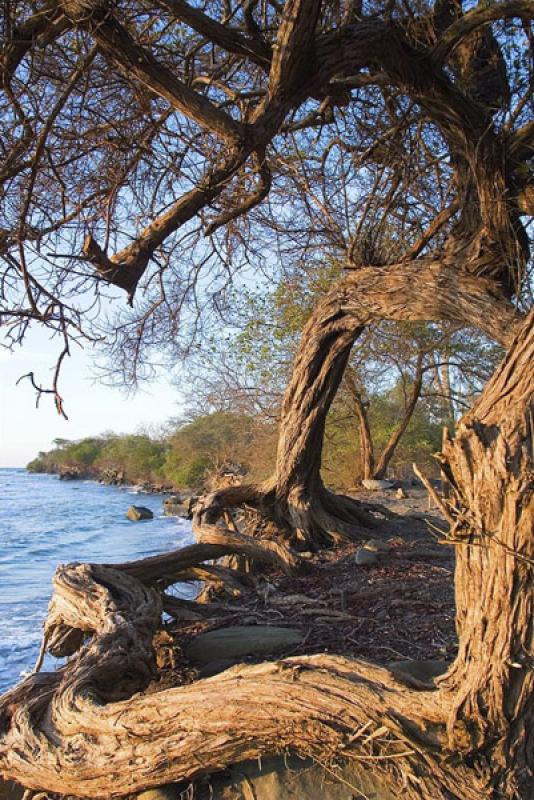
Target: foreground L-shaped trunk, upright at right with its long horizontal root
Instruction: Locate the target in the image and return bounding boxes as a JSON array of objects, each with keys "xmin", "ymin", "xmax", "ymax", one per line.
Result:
[{"xmin": 0, "ymin": 304, "xmax": 534, "ymax": 800}]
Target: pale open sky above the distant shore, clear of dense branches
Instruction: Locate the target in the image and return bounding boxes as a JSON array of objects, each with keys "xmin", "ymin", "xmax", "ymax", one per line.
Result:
[{"xmin": 0, "ymin": 332, "xmax": 184, "ymax": 467}]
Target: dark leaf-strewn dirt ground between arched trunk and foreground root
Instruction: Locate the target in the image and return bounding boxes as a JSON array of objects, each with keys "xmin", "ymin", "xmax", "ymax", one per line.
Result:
[{"xmin": 157, "ymin": 489, "xmax": 456, "ymax": 690}]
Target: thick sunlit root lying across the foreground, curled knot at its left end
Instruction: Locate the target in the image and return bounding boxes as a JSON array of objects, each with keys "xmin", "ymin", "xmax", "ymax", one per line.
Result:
[{"xmin": 0, "ymin": 565, "xmax": 480, "ymax": 798}]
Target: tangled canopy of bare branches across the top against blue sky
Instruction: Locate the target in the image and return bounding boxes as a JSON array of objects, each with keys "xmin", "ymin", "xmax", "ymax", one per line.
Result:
[{"xmin": 0, "ymin": 0, "xmax": 534, "ymax": 406}]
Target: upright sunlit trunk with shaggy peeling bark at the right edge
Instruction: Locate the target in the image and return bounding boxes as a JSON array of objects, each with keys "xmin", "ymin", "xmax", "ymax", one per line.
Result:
[{"xmin": 442, "ymin": 312, "xmax": 534, "ymax": 798}]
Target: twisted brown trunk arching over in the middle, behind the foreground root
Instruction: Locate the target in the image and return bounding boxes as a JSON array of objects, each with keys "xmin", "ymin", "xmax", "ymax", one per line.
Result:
[{"xmin": 269, "ymin": 259, "xmax": 518, "ymax": 545}]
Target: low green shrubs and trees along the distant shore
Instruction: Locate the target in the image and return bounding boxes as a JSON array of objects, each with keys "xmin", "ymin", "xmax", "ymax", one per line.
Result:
[{"xmin": 27, "ymin": 394, "xmax": 452, "ymax": 489}]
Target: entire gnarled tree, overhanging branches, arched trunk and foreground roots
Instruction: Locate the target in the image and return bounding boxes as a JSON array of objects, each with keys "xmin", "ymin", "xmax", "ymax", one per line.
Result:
[{"xmin": 0, "ymin": 0, "xmax": 534, "ymax": 800}]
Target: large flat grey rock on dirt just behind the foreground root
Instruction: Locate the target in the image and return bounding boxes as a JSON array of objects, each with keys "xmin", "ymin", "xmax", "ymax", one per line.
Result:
[{"xmin": 185, "ymin": 625, "xmax": 304, "ymax": 664}]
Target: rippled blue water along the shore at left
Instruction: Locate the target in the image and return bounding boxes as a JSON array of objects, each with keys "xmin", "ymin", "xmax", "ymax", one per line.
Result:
[{"xmin": 0, "ymin": 469, "xmax": 192, "ymax": 693}]
